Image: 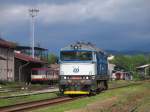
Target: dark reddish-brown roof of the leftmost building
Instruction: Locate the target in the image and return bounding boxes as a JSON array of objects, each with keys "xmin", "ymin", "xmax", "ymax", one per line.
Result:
[{"xmin": 0, "ymin": 38, "xmax": 16, "ymax": 48}]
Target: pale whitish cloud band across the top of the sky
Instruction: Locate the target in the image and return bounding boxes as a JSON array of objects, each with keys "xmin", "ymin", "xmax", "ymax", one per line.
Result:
[{"xmin": 0, "ymin": 0, "xmax": 150, "ymax": 24}]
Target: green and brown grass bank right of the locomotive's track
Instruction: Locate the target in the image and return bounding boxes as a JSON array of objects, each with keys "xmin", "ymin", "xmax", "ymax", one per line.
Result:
[{"xmin": 33, "ymin": 81, "xmax": 150, "ymax": 112}]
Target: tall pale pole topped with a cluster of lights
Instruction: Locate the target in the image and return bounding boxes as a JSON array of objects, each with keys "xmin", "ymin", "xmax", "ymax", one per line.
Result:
[{"xmin": 29, "ymin": 8, "xmax": 39, "ymax": 58}]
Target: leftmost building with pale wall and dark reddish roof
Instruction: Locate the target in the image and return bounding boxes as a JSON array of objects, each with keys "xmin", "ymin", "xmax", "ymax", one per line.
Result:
[{"xmin": 0, "ymin": 38, "xmax": 16, "ymax": 81}]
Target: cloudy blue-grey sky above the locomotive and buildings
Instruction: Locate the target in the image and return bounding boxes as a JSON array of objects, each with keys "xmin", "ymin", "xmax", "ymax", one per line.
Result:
[{"xmin": 0, "ymin": 0, "xmax": 150, "ymax": 53}]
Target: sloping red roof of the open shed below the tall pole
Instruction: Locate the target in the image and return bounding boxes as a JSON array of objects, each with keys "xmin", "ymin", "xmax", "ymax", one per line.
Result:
[{"xmin": 15, "ymin": 53, "xmax": 47, "ymax": 63}]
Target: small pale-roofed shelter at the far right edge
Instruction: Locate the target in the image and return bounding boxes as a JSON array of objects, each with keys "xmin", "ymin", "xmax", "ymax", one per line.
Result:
[{"xmin": 136, "ymin": 64, "xmax": 150, "ymax": 78}]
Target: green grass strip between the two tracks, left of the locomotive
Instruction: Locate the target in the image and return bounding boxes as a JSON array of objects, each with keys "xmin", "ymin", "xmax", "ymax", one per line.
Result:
[{"xmin": 0, "ymin": 93, "xmax": 57, "ymax": 107}]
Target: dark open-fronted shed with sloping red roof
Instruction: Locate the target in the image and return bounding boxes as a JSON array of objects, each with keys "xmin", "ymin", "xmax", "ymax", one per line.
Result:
[{"xmin": 15, "ymin": 53, "xmax": 47, "ymax": 82}]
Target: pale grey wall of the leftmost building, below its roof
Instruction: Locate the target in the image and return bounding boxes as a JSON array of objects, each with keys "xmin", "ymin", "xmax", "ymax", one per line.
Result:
[{"xmin": 0, "ymin": 47, "xmax": 14, "ymax": 81}]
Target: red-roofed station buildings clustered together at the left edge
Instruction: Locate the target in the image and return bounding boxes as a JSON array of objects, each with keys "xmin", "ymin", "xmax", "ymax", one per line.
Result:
[{"xmin": 0, "ymin": 38, "xmax": 48, "ymax": 82}]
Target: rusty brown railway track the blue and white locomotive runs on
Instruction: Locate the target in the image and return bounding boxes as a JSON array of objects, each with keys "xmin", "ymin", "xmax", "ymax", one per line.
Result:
[{"xmin": 0, "ymin": 83, "xmax": 141, "ymax": 112}]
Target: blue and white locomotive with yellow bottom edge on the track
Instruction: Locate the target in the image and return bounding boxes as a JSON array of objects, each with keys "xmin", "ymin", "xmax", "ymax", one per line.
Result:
[{"xmin": 59, "ymin": 42, "xmax": 109, "ymax": 95}]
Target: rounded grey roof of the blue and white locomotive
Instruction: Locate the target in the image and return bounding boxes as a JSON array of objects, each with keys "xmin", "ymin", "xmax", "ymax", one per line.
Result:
[{"xmin": 61, "ymin": 42, "xmax": 105, "ymax": 53}]
